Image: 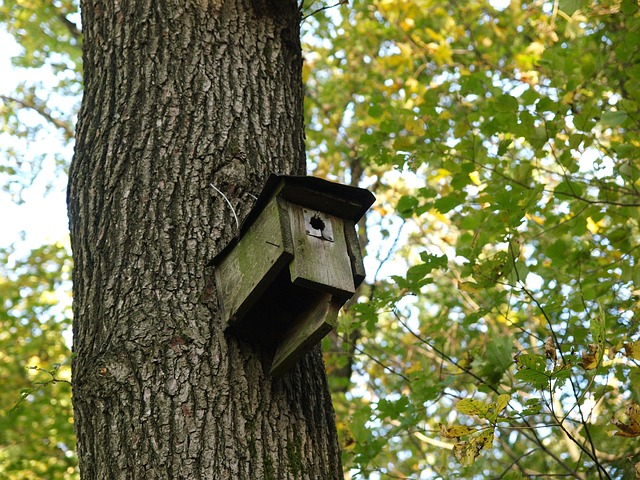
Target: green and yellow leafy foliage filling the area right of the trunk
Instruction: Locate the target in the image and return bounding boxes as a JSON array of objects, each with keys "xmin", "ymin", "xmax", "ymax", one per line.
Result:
[{"xmin": 307, "ymin": 0, "xmax": 640, "ymax": 478}]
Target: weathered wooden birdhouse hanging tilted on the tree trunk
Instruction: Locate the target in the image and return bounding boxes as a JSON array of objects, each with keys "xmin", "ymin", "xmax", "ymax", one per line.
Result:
[{"xmin": 214, "ymin": 175, "xmax": 375, "ymax": 376}]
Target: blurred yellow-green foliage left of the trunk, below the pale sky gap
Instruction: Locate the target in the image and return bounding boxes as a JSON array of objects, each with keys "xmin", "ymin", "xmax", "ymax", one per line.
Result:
[{"xmin": 0, "ymin": 245, "xmax": 77, "ymax": 479}]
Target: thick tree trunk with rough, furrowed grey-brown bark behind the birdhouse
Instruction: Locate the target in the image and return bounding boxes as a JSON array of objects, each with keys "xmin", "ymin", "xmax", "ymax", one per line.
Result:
[{"xmin": 68, "ymin": 0, "xmax": 342, "ymax": 479}]
